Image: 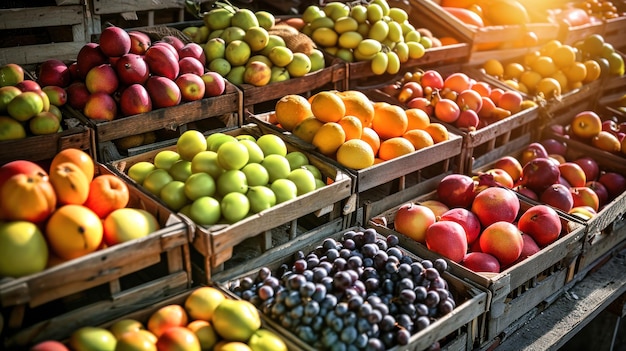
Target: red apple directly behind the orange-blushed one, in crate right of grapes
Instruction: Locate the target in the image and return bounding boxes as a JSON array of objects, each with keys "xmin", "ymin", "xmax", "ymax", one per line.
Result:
[{"xmin": 471, "ymin": 187, "xmax": 520, "ymax": 227}]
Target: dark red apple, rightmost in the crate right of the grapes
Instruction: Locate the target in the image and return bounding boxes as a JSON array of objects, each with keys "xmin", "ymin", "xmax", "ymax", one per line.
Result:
[{"xmin": 517, "ymin": 205, "xmax": 562, "ymax": 247}]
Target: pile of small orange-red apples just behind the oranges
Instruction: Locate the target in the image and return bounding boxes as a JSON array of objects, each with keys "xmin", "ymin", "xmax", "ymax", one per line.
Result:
[{"xmin": 378, "ymin": 69, "xmax": 536, "ymax": 131}]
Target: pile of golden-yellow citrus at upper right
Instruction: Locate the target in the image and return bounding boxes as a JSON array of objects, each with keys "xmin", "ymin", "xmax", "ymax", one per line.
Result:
[{"xmin": 482, "ymin": 34, "xmax": 624, "ymax": 99}]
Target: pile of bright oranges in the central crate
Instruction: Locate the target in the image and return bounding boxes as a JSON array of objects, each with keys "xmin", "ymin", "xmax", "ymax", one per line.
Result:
[{"xmin": 273, "ymin": 90, "xmax": 448, "ymax": 169}]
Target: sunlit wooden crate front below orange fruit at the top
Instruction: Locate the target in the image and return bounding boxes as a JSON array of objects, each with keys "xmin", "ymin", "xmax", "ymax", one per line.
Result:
[{"xmin": 410, "ymin": 0, "xmax": 559, "ymax": 51}]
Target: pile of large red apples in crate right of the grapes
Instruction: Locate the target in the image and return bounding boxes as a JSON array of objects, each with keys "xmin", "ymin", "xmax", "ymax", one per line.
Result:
[{"xmin": 393, "ymin": 174, "xmax": 565, "ymax": 273}]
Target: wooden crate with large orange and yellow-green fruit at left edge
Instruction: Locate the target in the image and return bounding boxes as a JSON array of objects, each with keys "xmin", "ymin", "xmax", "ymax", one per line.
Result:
[{"xmin": 0, "ymin": 155, "xmax": 192, "ymax": 350}]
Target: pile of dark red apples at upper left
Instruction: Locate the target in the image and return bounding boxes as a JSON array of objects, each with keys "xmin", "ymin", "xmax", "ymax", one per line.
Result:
[{"xmin": 38, "ymin": 26, "xmax": 225, "ymax": 121}]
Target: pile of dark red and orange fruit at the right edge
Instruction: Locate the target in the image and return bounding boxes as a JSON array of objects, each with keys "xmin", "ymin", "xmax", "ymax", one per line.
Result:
[{"xmin": 484, "ymin": 138, "xmax": 626, "ymax": 220}]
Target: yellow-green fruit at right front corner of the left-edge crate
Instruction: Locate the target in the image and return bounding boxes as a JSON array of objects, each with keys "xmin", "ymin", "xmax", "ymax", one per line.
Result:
[{"xmin": 102, "ymin": 208, "xmax": 160, "ymax": 245}]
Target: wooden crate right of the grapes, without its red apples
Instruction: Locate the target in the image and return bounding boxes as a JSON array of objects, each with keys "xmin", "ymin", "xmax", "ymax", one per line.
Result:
[{"xmin": 369, "ymin": 183, "xmax": 585, "ymax": 345}]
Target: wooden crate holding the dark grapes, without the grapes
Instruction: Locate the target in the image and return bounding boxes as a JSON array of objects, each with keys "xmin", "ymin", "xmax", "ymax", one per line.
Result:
[{"xmin": 214, "ymin": 226, "xmax": 489, "ymax": 351}]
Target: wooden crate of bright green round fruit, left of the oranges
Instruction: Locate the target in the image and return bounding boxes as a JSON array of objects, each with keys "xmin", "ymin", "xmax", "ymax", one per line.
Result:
[{"xmin": 112, "ymin": 124, "xmax": 352, "ymax": 283}]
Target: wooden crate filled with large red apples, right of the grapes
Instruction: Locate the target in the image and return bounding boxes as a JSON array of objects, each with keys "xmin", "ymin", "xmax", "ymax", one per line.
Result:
[{"xmin": 369, "ymin": 170, "xmax": 585, "ymax": 346}]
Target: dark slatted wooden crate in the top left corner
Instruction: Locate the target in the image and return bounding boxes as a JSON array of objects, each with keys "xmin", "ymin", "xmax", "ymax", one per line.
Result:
[{"xmin": 0, "ymin": 1, "xmax": 89, "ymax": 65}]
